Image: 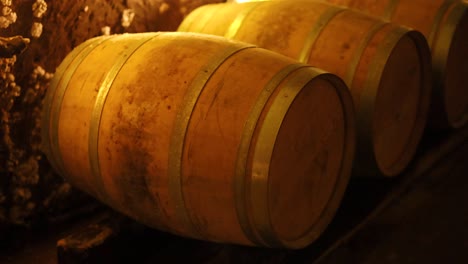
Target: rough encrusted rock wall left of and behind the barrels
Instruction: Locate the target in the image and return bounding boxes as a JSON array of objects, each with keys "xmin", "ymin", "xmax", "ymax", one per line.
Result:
[{"xmin": 0, "ymin": 0, "xmax": 223, "ymax": 225}]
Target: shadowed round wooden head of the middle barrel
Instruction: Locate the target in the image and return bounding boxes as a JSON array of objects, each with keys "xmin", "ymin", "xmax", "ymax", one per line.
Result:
[{"xmin": 372, "ymin": 31, "xmax": 431, "ymax": 176}]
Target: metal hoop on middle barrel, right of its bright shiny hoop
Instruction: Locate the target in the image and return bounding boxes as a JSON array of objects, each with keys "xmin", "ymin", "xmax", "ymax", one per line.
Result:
[{"xmin": 298, "ymin": 5, "xmax": 347, "ymax": 63}]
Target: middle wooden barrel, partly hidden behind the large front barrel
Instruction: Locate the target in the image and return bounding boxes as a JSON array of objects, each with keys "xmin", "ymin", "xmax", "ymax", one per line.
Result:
[{"xmin": 179, "ymin": 0, "xmax": 431, "ymax": 176}]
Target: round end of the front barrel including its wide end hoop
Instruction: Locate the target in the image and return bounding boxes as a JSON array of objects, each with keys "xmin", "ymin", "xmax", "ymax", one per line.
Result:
[{"xmin": 250, "ymin": 67, "xmax": 355, "ymax": 248}]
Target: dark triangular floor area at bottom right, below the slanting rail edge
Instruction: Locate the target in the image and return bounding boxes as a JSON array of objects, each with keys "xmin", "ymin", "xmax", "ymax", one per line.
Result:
[{"xmin": 320, "ymin": 141, "xmax": 468, "ymax": 264}]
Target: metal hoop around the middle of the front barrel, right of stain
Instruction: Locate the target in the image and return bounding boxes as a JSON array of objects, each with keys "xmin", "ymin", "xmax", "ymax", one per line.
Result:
[{"xmin": 168, "ymin": 43, "xmax": 255, "ymax": 238}]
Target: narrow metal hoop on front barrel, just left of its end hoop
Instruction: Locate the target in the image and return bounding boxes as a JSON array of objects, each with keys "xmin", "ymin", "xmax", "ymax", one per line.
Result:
[{"xmin": 233, "ymin": 64, "xmax": 307, "ymax": 246}]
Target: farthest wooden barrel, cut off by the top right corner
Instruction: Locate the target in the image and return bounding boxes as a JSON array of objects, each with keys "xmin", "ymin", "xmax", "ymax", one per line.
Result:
[{"xmin": 328, "ymin": 0, "xmax": 468, "ymax": 129}]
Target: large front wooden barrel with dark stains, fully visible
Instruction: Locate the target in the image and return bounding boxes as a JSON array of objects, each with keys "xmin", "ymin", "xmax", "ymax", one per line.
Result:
[{"xmin": 42, "ymin": 33, "xmax": 355, "ymax": 248}]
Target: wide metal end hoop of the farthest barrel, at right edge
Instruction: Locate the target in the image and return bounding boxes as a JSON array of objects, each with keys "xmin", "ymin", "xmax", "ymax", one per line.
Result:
[{"xmin": 432, "ymin": 2, "xmax": 468, "ymax": 118}]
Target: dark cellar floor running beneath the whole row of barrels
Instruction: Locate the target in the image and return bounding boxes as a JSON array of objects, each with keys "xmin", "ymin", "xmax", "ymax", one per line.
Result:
[{"xmin": 0, "ymin": 127, "xmax": 468, "ymax": 264}]
